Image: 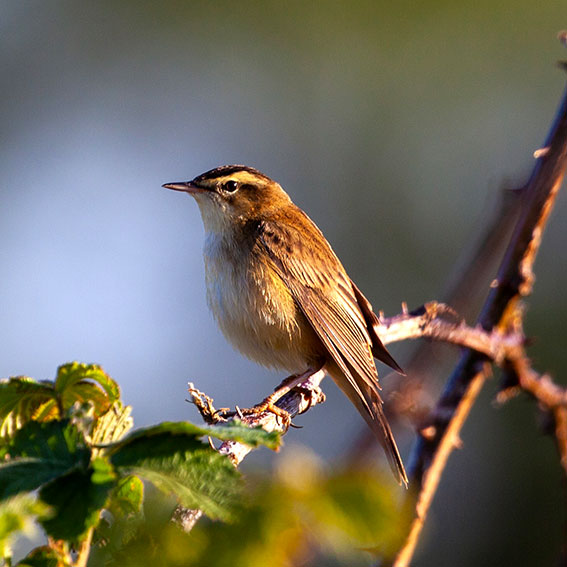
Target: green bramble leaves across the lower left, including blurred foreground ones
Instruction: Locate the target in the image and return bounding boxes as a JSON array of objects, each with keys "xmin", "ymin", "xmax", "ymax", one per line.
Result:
[{"xmin": 0, "ymin": 362, "xmax": 401, "ymax": 567}]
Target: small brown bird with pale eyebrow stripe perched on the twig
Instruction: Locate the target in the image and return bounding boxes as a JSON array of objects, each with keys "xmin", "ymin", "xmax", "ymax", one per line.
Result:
[{"xmin": 163, "ymin": 165, "xmax": 408, "ymax": 486}]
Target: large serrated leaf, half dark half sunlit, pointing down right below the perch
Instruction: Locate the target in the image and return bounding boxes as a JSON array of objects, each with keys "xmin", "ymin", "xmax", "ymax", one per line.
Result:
[{"xmin": 110, "ymin": 424, "xmax": 240, "ymax": 520}]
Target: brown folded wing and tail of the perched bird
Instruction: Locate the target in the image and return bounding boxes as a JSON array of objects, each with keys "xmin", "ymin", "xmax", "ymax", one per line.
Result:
[{"xmin": 257, "ymin": 212, "xmax": 407, "ymax": 484}]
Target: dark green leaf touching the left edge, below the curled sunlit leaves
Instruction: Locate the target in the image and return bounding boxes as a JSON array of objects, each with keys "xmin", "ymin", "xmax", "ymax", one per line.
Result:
[{"xmin": 0, "ymin": 420, "xmax": 90, "ymax": 500}]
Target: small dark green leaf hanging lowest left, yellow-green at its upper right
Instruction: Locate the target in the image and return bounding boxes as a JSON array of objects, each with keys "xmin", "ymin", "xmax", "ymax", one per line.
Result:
[{"xmin": 39, "ymin": 459, "xmax": 116, "ymax": 542}]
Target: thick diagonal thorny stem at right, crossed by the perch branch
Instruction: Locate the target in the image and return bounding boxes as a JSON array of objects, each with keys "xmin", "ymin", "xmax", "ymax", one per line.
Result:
[{"xmin": 392, "ymin": 82, "xmax": 567, "ymax": 567}]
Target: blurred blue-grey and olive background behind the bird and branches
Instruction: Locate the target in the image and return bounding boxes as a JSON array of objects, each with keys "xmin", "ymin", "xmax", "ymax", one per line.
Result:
[{"xmin": 0, "ymin": 0, "xmax": 567, "ymax": 567}]
